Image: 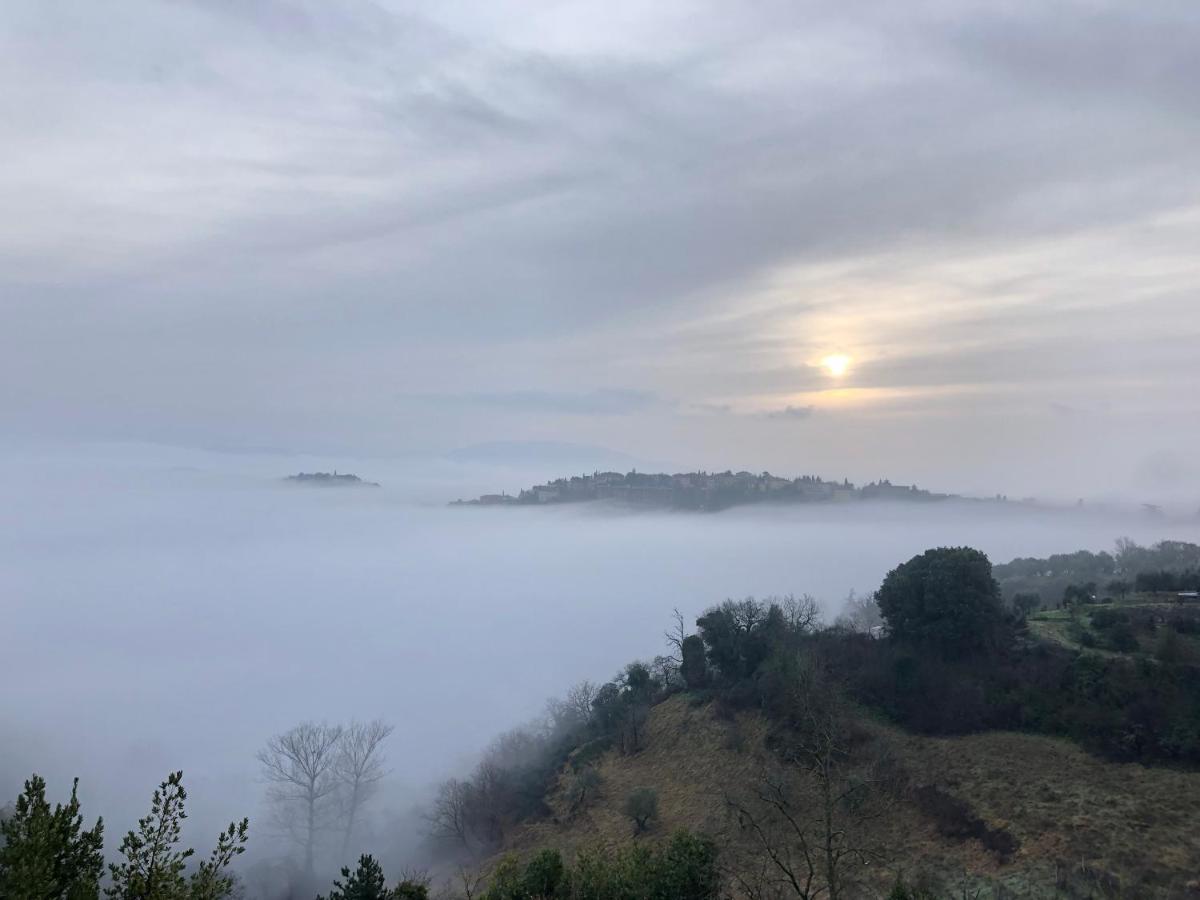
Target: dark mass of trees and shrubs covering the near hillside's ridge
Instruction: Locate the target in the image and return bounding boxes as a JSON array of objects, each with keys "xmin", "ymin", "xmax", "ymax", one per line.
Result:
[{"xmin": 420, "ymin": 545, "xmax": 1200, "ymax": 897}]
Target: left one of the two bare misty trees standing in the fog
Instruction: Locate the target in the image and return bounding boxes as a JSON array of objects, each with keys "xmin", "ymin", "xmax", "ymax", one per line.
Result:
[{"xmin": 258, "ymin": 722, "xmax": 342, "ymax": 880}]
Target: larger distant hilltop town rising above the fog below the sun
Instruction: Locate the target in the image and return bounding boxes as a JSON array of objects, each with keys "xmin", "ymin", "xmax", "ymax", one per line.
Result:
[{"xmin": 451, "ymin": 470, "xmax": 955, "ymax": 510}]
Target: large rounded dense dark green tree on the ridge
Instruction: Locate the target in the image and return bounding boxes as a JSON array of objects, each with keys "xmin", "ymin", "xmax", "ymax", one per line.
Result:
[{"xmin": 875, "ymin": 547, "xmax": 1008, "ymax": 659}]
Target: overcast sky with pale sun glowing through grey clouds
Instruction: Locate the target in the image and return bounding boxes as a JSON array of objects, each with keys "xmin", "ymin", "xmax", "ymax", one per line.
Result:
[{"xmin": 0, "ymin": 0, "xmax": 1200, "ymax": 496}]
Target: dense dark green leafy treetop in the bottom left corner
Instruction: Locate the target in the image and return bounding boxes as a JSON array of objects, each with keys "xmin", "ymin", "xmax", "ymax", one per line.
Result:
[{"xmin": 0, "ymin": 775, "xmax": 104, "ymax": 900}]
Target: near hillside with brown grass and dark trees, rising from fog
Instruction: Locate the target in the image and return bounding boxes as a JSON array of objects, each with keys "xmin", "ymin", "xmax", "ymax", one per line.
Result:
[{"xmin": 431, "ymin": 547, "xmax": 1200, "ymax": 900}]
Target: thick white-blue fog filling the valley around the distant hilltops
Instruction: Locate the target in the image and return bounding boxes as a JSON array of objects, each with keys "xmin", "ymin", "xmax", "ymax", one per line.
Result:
[{"xmin": 0, "ymin": 446, "xmax": 1200, "ymax": 873}]
